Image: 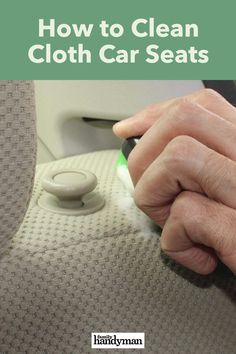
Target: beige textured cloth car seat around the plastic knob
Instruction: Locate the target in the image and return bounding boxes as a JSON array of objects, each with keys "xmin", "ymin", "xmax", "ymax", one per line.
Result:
[{"xmin": 0, "ymin": 82, "xmax": 236, "ymax": 354}]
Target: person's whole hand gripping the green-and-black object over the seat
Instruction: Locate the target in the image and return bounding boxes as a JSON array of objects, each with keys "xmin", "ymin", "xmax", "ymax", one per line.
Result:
[{"xmin": 114, "ymin": 90, "xmax": 236, "ymax": 274}]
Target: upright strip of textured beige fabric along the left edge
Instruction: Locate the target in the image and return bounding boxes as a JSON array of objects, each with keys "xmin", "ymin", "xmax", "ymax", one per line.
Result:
[{"xmin": 0, "ymin": 81, "xmax": 36, "ymax": 253}]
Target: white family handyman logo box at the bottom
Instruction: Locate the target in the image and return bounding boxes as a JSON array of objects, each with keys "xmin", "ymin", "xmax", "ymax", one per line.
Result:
[{"xmin": 91, "ymin": 332, "xmax": 145, "ymax": 349}]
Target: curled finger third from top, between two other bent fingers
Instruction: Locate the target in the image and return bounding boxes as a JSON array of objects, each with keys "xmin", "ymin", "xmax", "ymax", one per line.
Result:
[{"xmin": 134, "ymin": 136, "xmax": 236, "ymax": 226}]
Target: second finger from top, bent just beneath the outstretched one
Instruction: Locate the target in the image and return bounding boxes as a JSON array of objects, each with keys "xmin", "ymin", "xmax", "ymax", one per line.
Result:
[{"xmin": 129, "ymin": 100, "xmax": 236, "ymax": 183}]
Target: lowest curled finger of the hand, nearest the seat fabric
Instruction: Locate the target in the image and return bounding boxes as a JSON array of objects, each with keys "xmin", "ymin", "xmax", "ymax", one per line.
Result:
[{"xmin": 161, "ymin": 192, "xmax": 236, "ymax": 274}]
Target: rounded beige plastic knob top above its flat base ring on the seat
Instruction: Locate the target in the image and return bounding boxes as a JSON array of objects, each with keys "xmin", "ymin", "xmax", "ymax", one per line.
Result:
[{"xmin": 42, "ymin": 169, "xmax": 97, "ymax": 201}]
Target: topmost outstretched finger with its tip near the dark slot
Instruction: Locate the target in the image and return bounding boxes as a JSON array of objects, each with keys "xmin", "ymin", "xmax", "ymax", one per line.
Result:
[{"xmin": 113, "ymin": 89, "xmax": 236, "ymax": 138}]
